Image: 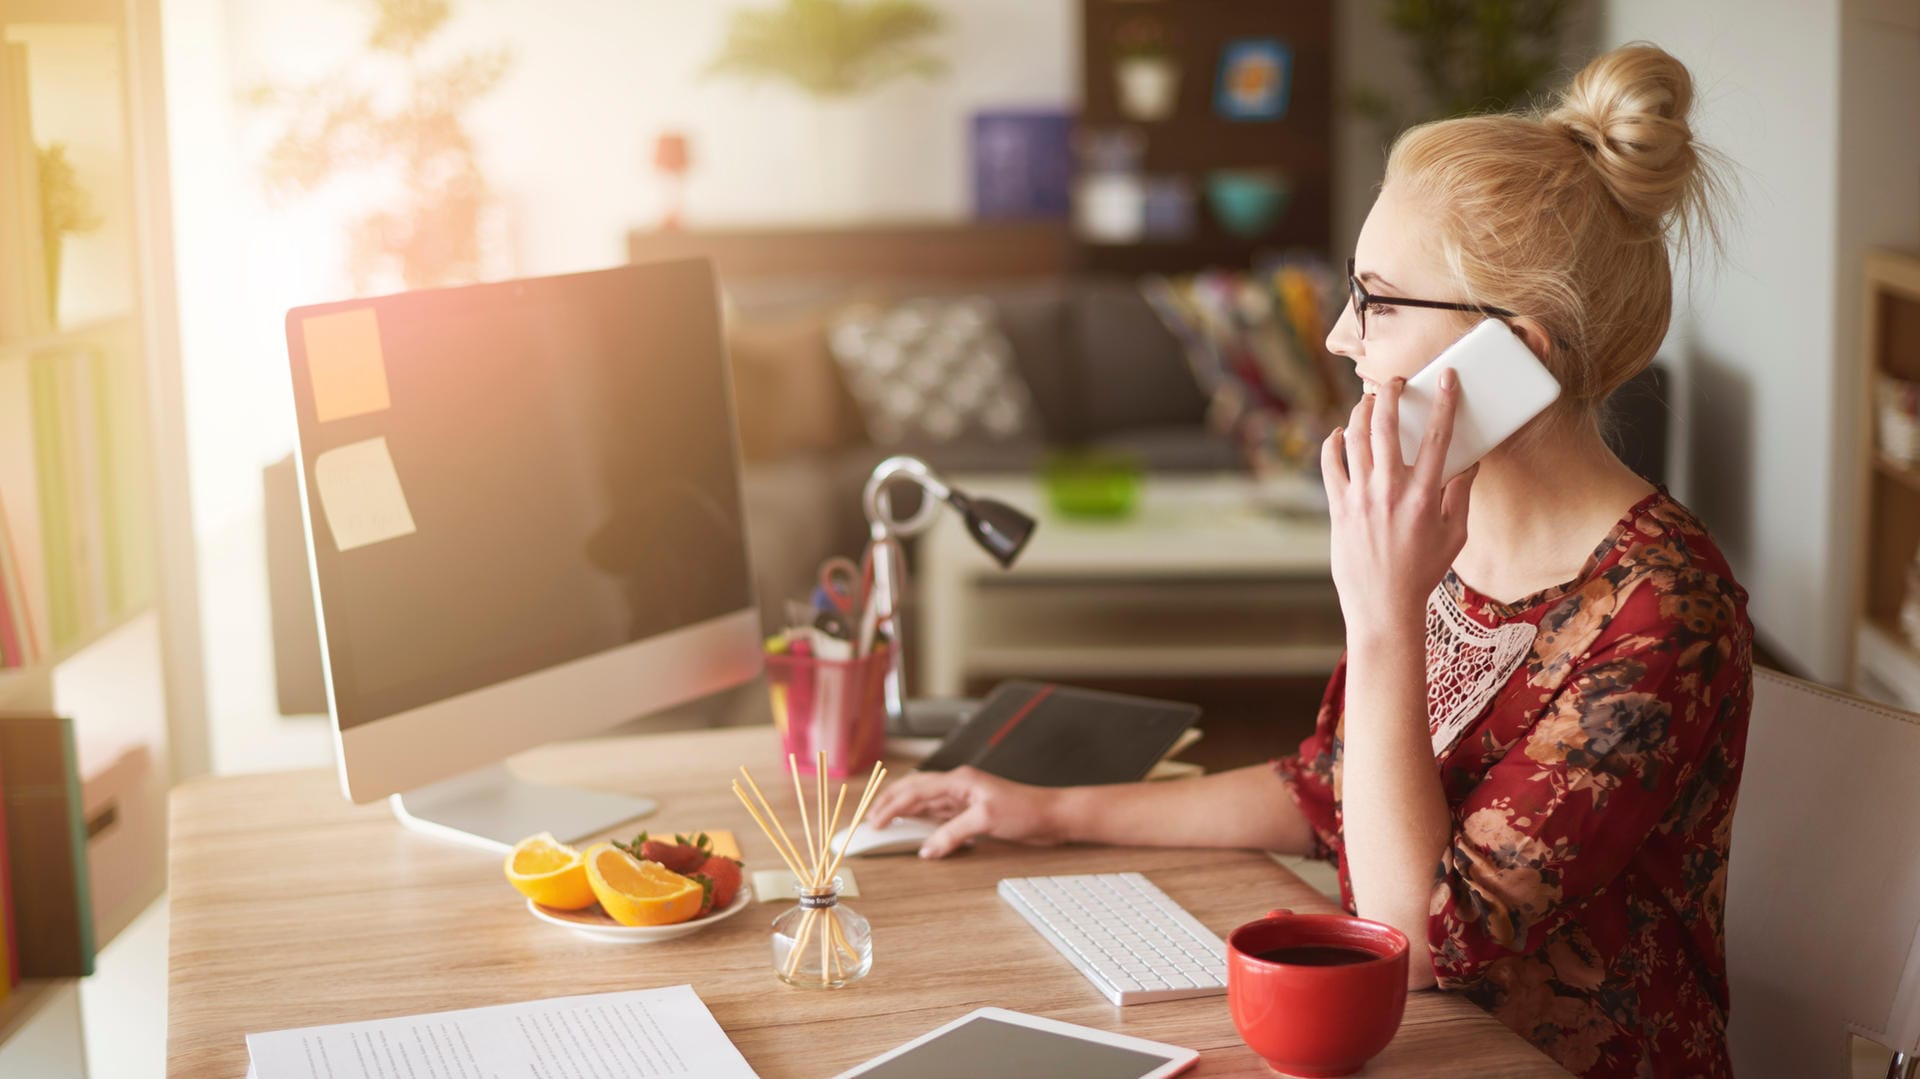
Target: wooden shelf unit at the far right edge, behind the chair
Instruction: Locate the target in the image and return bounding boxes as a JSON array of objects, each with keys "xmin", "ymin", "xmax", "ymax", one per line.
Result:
[{"xmin": 1853, "ymin": 250, "xmax": 1920, "ymax": 708}]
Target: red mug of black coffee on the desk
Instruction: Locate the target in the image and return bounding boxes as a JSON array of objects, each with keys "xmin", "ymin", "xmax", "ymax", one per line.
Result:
[{"xmin": 1227, "ymin": 910, "xmax": 1407, "ymax": 1079}]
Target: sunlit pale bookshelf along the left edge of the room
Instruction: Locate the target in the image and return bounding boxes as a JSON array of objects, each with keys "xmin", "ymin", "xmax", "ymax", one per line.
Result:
[{"xmin": 0, "ymin": 0, "xmax": 204, "ymax": 1075}]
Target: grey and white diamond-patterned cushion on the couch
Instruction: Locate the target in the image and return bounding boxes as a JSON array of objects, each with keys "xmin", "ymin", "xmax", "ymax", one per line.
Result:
[{"xmin": 829, "ymin": 296, "xmax": 1039, "ymax": 447}]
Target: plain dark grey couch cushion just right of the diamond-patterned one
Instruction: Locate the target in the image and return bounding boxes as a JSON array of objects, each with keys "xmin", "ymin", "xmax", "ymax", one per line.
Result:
[{"xmin": 1069, "ymin": 280, "xmax": 1206, "ymax": 438}]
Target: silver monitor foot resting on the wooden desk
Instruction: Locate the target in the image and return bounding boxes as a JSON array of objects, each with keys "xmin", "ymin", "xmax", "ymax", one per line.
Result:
[{"xmin": 388, "ymin": 764, "xmax": 660, "ymax": 854}]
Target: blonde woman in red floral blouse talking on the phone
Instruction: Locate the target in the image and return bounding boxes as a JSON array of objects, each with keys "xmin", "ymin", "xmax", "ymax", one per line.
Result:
[{"xmin": 874, "ymin": 44, "xmax": 1751, "ymax": 1077}]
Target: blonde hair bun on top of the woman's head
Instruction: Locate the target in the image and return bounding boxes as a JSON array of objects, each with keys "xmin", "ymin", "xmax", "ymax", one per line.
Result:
[{"xmin": 1544, "ymin": 42, "xmax": 1709, "ymax": 232}]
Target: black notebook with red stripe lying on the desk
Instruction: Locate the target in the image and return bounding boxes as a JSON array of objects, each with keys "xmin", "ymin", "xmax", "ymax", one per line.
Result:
[{"xmin": 920, "ymin": 682, "xmax": 1200, "ymax": 787}]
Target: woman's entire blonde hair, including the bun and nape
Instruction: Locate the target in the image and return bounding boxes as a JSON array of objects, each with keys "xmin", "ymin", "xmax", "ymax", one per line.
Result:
[{"xmin": 1382, "ymin": 44, "xmax": 1724, "ymax": 407}]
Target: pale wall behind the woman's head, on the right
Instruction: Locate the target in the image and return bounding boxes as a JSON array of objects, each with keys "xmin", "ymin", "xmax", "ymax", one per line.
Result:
[{"xmin": 1605, "ymin": 0, "xmax": 1920, "ymax": 682}]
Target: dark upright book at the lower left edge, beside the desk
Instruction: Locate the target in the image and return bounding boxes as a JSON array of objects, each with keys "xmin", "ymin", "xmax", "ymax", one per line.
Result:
[{"xmin": 0, "ymin": 712, "xmax": 94, "ymax": 977}]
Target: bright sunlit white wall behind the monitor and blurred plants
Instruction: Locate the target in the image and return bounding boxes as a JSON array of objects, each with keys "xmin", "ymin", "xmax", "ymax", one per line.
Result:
[{"xmin": 163, "ymin": 0, "xmax": 1079, "ymax": 770}]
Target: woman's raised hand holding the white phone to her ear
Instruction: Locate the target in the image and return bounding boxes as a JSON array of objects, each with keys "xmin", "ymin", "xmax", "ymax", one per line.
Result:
[{"xmin": 1321, "ymin": 371, "xmax": 1480, "ymax": 639}]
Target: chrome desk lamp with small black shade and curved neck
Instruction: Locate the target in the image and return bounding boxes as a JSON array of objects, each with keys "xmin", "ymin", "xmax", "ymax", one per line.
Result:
[{"xmin": 860, "ymin": 457, "xmax": 1037, "ymax": 728}]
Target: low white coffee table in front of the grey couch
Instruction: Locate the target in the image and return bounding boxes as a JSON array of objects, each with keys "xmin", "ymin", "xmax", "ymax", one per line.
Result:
[{"xmin": 906, "ymin": 474, "xmax": 1344, "ymax": 697}]
